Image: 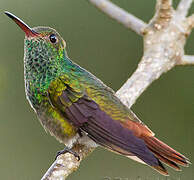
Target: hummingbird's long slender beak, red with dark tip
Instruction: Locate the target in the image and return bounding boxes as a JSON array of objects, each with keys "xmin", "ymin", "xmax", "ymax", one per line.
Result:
[{"xmin": 5, "ymin": 11, "xmax": 39, "ymax": 37}]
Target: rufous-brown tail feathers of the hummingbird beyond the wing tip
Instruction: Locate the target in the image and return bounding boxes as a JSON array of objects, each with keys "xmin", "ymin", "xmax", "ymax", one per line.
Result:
[{"xmin": 143, "ymin": 136, "xmax": 190, "ymax": 174}]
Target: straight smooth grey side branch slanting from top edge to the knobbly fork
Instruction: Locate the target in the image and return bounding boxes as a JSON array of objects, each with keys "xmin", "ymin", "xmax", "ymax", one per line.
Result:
[{"xmin": 89, "ymin": 0, "xmax": 146, "ymax": 35}]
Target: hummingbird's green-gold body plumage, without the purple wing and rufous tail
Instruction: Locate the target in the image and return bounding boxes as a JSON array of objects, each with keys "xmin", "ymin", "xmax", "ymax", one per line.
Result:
[{"xmin": 24, "ymin": 27, "xmax": 136, "ymax": 142}]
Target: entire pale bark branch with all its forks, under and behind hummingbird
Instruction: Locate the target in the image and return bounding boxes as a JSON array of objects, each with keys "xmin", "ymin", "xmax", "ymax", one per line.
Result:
[{"xmin": 42, "ymin": 0, "xmax": 194, "ymax": 180}]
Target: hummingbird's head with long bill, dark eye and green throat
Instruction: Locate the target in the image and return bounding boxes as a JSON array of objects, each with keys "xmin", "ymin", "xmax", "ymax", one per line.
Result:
[{"xmin": 5, "ymin": 12, "xmax": 67, "ymax": 90}]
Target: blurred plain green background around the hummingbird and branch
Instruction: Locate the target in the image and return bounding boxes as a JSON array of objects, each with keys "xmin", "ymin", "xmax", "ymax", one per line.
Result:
[{"xmin": 0, "ymin": 0, "xmax": 194, "ymax": 180}]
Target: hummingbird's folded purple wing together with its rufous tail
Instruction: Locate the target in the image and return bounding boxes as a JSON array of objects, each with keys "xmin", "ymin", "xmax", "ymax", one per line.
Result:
[{"xmin": 48, "ymin": 79, "xmax": 189, "ymax": 175}]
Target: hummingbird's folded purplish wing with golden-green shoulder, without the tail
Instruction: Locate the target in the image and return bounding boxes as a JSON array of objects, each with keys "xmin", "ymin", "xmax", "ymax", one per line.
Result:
[{"xmin": 48, "ymin": 79, "xmax": 159, "ymax": 166}]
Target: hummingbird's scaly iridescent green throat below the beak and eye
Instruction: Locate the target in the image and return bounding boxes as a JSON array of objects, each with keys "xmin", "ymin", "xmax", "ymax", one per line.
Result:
[{"xmin": 24, "ymin": 38, "xmax": 72, "ymax": 105}]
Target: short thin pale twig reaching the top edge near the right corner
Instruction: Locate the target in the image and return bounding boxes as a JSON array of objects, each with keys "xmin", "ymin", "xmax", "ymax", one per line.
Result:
[{"xmin": 177, "ymin": 0, "xmax": 193, "ymax": 18}]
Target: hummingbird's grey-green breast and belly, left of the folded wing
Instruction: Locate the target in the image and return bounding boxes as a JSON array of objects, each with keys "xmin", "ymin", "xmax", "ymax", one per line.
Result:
[{"xmin": 25, "ymin": 81, "xmax": 77, "ymax": 146}]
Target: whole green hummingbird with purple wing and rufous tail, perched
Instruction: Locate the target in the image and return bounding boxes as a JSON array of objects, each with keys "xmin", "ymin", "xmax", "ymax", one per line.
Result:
[{"xmin": 5, "ymin": 11, "xmax": 190, "ymax": 176}]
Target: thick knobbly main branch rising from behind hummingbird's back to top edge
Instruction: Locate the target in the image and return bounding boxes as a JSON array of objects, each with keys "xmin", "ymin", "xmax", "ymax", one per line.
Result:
[{"xmin": 117, "ymin": 0, "xmax": 185, "ymax": 107}]
